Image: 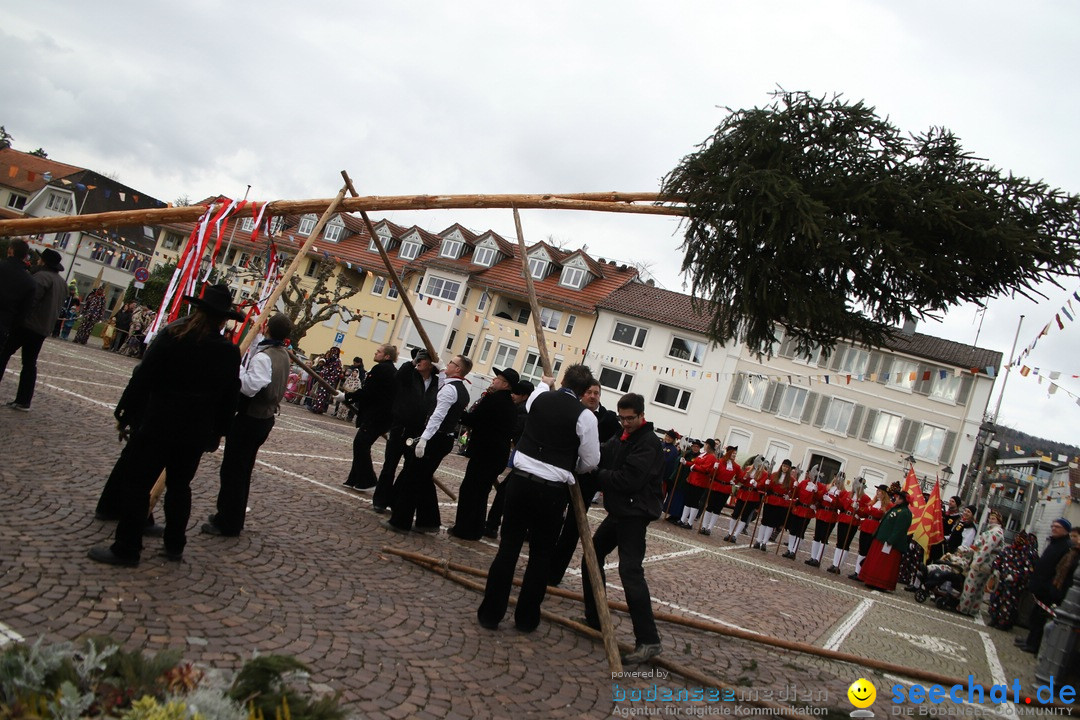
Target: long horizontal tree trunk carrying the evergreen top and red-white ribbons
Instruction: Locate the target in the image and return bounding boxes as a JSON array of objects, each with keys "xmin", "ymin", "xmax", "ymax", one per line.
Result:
[{"xmin": 0, "ymin": 192, "xmax": 688, "ymax": 235}]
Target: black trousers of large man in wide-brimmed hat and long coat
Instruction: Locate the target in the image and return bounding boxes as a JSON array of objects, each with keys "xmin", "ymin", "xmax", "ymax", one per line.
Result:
[{"xmin": 112, "ymin": 430, "xmax": 203, "ymax": 559}]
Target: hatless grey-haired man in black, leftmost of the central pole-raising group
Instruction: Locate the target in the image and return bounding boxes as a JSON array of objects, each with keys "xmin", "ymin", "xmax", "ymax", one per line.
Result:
[{"xmin": 341, "ymin": 345, "xmax": 397, "ymax": 490}]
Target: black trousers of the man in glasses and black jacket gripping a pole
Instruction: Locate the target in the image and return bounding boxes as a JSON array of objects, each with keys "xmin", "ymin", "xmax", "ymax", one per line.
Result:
[{"xmin": 581, "ymin": 515, "xmax": 660, "ymax": 644}]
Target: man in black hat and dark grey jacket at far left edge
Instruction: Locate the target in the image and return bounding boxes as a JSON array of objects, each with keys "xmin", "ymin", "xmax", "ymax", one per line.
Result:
[{"xmin": 0, "ymin": 247, "xmax": 67, "ymax": 412}]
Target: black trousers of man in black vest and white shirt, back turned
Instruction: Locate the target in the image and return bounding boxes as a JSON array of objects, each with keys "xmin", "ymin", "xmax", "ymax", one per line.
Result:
[{"xmin": 476, "ymin": 471, "xmax": 569, "ymax": 631}]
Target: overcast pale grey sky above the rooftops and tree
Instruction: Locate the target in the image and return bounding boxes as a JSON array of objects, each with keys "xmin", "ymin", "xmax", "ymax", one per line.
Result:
[{"xmin": 0, "ymin": 0, "xmax": 1080, "ymax": 444}]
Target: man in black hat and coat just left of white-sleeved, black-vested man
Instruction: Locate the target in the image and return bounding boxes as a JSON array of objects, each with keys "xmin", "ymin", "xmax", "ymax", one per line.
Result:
[{"xmin": 448, "ymin": 367, "xmax": 521, "ymax": 540}]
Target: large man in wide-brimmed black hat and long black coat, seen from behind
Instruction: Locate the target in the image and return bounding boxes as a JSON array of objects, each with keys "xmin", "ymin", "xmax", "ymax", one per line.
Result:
[{"xmin": 87, "ymin": 285, "xmax": 244, "ymax": 567}]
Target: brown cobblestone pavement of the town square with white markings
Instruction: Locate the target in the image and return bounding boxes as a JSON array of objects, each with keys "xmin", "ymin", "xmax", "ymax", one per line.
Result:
[{"xmin": 0, "ymin": 339, "xmax": 1067, "ymax": 718}]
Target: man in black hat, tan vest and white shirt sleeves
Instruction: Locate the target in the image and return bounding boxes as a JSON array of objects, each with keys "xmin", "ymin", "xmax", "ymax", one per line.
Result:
[{"xmin": 202, "ymin": 313, "xmax": 293, "ymax": 536}]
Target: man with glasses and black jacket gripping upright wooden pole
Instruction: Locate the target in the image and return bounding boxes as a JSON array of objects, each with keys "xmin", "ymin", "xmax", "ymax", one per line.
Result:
[{"xmin": 582, "ymin": 393, "xmax": 664, "ymax": 664}]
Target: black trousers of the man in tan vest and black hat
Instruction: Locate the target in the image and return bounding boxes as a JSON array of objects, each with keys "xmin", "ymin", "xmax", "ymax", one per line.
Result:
[{"xmin": 213, "ymin": 415, "xmax": 273, "ymax": 535}]
